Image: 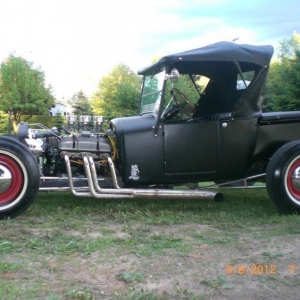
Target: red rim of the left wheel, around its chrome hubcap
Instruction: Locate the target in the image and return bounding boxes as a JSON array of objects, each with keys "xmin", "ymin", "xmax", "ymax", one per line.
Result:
[{"xmin": 0, "ymin": 154, "xmax": 24, "ymax": 204}]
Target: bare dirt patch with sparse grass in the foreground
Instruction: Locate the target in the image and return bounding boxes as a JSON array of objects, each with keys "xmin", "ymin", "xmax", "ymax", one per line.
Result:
[{"xmin": 0, "ymin": 222, "xmax": 300, "ymax": 300}]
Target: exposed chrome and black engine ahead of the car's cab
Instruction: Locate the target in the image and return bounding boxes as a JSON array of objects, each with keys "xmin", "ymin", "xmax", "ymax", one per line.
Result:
[{"xmin": 19, "ymin": 116, "xmax": 116, "ymax": 176}]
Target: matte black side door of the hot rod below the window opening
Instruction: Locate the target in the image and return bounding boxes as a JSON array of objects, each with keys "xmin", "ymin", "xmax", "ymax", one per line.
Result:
[{"xmin": 163, "ymin": 120, "xmax": 218, "ymax": 175}]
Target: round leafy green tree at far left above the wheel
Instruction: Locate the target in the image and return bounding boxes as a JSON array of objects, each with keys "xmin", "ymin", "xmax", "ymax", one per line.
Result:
[{"xmin": 0, "ymin": 55, "xmax": 54, "ymax": 128}]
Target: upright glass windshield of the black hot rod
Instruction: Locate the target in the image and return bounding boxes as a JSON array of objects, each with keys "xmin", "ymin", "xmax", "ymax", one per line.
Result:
[{"xmin": 140, "ymin": 71, "xmax": 166, "ymax": 114}]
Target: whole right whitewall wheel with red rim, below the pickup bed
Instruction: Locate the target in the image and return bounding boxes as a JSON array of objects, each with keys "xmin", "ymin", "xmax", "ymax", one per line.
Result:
[{"xmin": 266, "ymin": 141, "xmax": 300, "ymax": 213}]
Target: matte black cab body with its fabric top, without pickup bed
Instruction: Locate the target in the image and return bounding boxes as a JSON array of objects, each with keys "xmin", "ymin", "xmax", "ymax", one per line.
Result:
[{"xmin": 112, "ymin": 42, "xmax": 273, "ymax": 185}]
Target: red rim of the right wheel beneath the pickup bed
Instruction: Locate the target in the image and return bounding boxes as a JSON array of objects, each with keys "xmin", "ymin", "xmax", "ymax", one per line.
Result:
[{"xmin": 286, "ymin": 157, "xmax": 300, "ymax": 203}]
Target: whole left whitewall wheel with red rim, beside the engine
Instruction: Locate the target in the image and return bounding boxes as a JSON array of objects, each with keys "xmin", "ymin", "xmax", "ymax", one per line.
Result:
[{"xmin": 0, "ymin": 137, "xmax": 40, "ymax": 219}]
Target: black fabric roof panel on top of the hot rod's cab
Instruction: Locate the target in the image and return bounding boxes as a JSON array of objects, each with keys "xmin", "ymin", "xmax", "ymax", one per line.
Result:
[{"xmin": 138, "ymin": 42, "xmax": 274, "ymax": 75}]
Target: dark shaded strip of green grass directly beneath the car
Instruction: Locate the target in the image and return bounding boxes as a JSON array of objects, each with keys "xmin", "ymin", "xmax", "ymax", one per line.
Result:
[{"xmin": 26, "ymin": 189, "xmax": 292, "ymax": 224}]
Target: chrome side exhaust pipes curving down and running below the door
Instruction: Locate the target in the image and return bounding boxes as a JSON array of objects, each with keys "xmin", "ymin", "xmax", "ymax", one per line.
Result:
[{"xmin": 64, "ymin": 153, "xmax": 223, "ymax": 201}]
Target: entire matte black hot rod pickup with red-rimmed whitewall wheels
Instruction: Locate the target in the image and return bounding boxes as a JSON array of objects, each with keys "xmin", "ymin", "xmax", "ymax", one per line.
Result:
[{"xmin": 0, "ymin": 42, "xmax": 300, "ymax": 218}]
